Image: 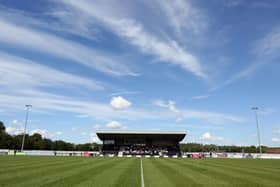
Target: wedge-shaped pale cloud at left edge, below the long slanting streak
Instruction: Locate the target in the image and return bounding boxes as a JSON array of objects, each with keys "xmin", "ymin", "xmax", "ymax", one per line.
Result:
[{"xmin": 0, "ymin": 52, "xmax": 104, "ymax": 91}]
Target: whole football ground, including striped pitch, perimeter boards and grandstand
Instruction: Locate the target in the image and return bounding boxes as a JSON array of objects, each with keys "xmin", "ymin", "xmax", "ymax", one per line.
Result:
[{"xmin": 0, "ymin": 131, "xmax": 280, "ymax": 187}]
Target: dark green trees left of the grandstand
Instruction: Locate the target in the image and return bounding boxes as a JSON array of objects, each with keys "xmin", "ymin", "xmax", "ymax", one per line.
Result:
[{"xmin": 0, "ymin": 121, "xmax": 101, "ymax": 151}]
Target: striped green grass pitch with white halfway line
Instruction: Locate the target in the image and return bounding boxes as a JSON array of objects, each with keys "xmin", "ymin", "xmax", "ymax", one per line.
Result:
[{"xmin": 0, "ymin": 156, "xmax": 280, "ymax": 187}]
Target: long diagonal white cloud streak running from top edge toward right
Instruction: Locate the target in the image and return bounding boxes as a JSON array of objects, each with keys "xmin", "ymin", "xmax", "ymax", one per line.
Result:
[{"xmin": 55, "ymin": 1, "xmax": 208, "ymax": 79}]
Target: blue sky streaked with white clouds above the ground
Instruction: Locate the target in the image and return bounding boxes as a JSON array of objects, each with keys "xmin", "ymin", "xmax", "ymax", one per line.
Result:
[{"xmin": 0, "ymin": 0, "xmax": 280, "ymax": 146}]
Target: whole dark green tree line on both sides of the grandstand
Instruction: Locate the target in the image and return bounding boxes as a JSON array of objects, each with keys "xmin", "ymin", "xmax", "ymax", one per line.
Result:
[{"xmin": 0, "ymin": 121, "xmax": 268, "ymax": 153}]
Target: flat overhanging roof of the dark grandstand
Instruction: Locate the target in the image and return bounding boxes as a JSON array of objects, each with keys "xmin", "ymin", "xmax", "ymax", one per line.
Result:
[{"xmin": 96, "ymin": 131, "xmax": 186, "ymax": 141}]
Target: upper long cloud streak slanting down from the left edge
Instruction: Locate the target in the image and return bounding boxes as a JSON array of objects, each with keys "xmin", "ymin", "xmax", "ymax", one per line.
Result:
[{"xmin": 0, "ymin": 19, "xmax": 138, "ymax": 76}]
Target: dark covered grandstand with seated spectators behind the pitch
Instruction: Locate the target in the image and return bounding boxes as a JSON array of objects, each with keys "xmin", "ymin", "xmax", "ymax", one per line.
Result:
[{"xmin": 96, "ymin": 131, "xmax": 186, "ymax": 156}]
